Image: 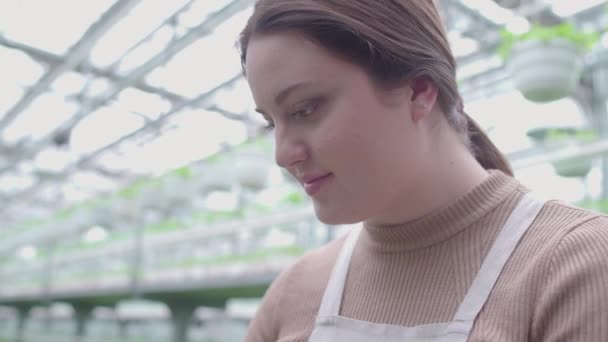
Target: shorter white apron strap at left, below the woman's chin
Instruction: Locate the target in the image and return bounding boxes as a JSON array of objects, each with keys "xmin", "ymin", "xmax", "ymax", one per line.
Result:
[{"xmin": 317, "ymin": 225, "xmax": 363, "ymax": 317}]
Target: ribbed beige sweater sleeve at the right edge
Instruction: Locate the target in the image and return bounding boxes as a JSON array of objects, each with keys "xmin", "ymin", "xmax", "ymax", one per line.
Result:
[{"xmin": 531, "ymin": 216, "xmax": 608, "ymax": 342}]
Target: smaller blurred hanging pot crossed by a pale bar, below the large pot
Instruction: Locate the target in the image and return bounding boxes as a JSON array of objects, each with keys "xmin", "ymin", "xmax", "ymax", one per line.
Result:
[{"xmin": 528, "ymin": 127, "xmax": 597, "ymax": 178}]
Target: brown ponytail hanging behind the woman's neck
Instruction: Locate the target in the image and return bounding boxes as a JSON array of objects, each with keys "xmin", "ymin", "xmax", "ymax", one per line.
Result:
[{"xmin": 462, "ymin": 111, "xmax": 513, "ymax": 176}]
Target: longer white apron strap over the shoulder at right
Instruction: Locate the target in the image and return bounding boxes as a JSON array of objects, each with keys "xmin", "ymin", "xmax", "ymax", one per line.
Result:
[{"xmin": 453, "ymin": 193, "xmax": 546, "ymax": 322}]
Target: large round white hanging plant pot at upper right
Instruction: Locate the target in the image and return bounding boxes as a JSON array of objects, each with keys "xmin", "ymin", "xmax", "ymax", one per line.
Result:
[{"xmin": 507, "ymin": 38, "xmax": 583, "ymax": 102}]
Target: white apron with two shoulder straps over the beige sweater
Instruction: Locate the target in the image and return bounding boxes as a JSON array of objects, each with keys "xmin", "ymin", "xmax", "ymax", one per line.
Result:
[{"xmin": 309, "ymin": 193, "xmax": 545, "ymax": 342}]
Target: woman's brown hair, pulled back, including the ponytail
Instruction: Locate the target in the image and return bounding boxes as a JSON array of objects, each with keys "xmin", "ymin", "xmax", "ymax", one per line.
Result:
[{"xmin": 239, "ymin": 0, "xmax": 513, "ymax": 175}]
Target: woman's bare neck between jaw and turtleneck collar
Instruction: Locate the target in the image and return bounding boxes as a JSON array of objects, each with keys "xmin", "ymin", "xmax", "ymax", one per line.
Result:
[{"xmin": 366, "ymin": 119, "xmax": 489, "ymax": 226}]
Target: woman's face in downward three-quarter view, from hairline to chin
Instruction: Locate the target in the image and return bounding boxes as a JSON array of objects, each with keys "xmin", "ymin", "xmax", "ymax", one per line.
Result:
[{"xmin": 246, "ymin": 33, "xmax": 425, "ymax": 224}]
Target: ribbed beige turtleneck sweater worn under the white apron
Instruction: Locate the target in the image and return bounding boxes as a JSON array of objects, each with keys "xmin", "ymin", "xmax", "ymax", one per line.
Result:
[{"xmin": 245, "ymin": 171, "xmax": 608, "ymax": 342}]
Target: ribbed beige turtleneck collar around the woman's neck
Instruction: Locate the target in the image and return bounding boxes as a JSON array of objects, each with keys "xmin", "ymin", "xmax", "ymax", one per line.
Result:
[{"xmin": 361, "ymin": 170, "xmax": 520, "ymax": 252}]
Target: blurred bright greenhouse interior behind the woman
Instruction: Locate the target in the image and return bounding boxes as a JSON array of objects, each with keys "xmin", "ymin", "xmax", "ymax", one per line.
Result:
[{"xmin": 0, "ymin": 0, "xmax": 608, "ymax": 342}]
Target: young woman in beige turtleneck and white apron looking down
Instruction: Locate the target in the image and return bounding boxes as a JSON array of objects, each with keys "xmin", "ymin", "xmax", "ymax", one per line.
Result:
[{"xmin": 240, "ymin": 0, "xmax": 608, "ymax": 342}]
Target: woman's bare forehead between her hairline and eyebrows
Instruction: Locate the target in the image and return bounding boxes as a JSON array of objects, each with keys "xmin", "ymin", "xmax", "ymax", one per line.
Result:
[{"xmin": 245, "ymin": 32, "xmax": 358, "ymax": 102}]
